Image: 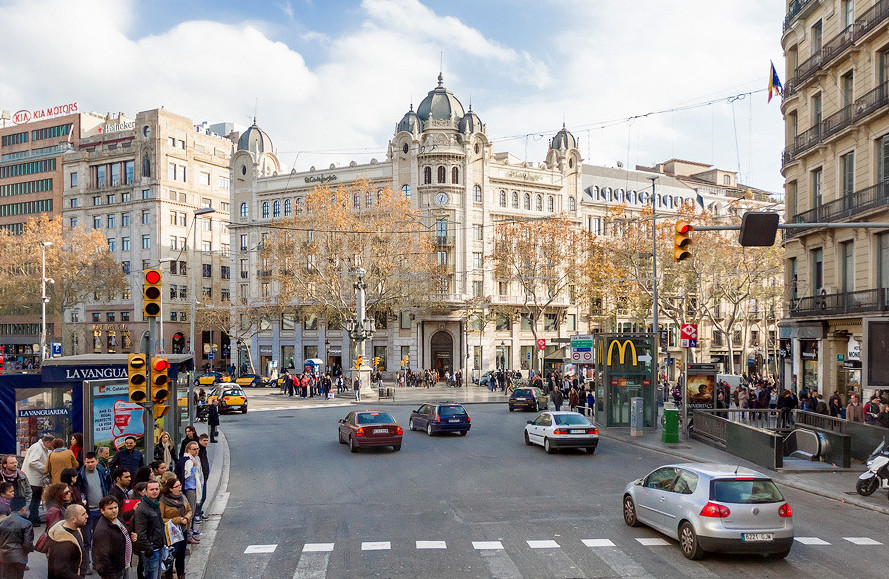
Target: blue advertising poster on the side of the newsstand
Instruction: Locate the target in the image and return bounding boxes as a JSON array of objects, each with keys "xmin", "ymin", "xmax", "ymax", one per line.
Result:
[{"xmin": 93, "ymin": 382, "xmax": 145, "ymax": 451}]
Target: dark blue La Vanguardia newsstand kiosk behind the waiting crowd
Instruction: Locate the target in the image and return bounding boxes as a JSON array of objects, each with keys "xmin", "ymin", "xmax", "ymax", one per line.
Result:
[{"xmin": 0, "ymin": 354, "xmax": 191, "ymax": 455}]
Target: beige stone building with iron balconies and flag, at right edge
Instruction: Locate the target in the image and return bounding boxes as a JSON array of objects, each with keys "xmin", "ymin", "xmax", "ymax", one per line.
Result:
[{"xmin": 781, "ymin": 0, "xmax": 889, "ymax": 394}]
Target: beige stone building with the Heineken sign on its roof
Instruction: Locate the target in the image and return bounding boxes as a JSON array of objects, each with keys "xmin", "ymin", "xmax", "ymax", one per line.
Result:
[{"xmin": 62, "ymin": 109, "xmax": 233, "ymax": 366}]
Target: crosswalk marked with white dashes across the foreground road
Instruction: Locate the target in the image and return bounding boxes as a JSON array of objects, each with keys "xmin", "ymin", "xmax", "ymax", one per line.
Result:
[{"xmin": 244, "ymin": 535, "xmax": 885, "ymax": 579}]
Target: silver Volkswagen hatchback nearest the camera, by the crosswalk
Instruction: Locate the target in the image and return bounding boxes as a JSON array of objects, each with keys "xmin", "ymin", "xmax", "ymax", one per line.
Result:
[{"xmin": 623, "ymin": 463, "xmax": 793, "ymax": 559}]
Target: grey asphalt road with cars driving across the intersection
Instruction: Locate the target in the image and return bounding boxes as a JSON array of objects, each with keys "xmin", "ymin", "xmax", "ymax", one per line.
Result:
[{"xmin": 205, "ymin": 404, "xmax": 889, "ymax": 579}]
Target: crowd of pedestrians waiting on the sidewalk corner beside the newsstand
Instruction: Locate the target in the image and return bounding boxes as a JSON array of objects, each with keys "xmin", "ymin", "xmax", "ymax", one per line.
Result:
[{"xmin": 0, "ymin": 422, "xmax": 219, "ymax": 579}]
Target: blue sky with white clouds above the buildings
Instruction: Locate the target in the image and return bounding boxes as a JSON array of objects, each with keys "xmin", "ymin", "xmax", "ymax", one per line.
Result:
[{"xmin": 0, "ymin": 0, "xmax": 785, "ymax": 194}]
